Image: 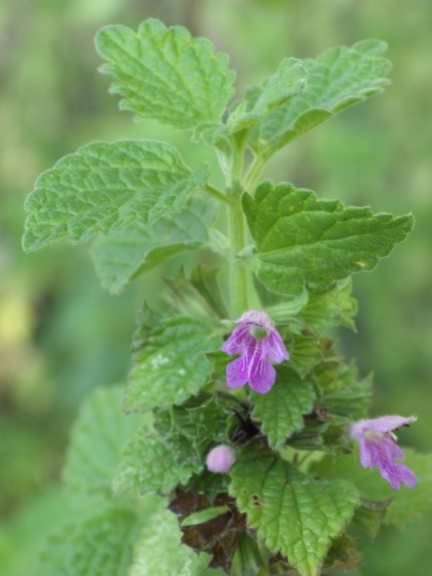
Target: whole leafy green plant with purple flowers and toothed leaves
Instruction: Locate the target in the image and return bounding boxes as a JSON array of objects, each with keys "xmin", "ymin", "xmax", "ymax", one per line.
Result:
[{"xmin": 23, "ymin": 20, "xmax": 432, "ymax": 576}]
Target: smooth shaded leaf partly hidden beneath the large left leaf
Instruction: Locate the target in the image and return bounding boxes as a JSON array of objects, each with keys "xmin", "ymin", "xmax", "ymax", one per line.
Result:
[{"xmin": 91, "ymin": 202, "xmax": 209, "ymax": 294}]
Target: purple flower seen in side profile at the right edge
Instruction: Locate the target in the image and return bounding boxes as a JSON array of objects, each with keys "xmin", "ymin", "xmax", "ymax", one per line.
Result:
[{"xmin": 350, "ymin": 416, "xmax": 417, "ymax": 490}]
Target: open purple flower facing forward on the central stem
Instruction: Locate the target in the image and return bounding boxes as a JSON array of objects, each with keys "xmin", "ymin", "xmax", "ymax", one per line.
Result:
[{"xmin": 222, "ymin": 310, "xmax": 289, "ymax": 394}]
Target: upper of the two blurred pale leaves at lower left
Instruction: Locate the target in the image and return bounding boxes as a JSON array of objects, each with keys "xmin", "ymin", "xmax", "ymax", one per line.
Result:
[{"xmin": 64, "ymin": 388, "xmax": 143, "ymax": 496}]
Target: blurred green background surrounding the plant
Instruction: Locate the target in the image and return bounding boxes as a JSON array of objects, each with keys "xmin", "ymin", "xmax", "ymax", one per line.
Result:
[{"xmin": 0, "ymin": 0, "xmax": 432, "ymax": 576}]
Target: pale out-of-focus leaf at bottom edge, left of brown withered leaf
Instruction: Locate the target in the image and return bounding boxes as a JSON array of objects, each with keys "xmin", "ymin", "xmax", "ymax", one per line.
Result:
[{"xmin": 130, "ymin": 500, "xmax": 223, "ymax": 576}]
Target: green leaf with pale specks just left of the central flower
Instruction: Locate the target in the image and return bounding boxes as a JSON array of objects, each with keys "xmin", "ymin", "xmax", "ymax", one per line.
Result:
[{"xmin": 127, "ymin": 316, "xmax": 222, "ymax": 410}]
